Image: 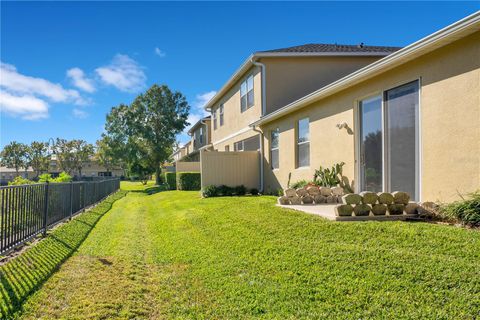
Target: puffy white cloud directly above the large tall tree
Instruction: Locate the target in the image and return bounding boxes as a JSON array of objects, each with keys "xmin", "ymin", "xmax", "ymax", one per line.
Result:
[{"xmin": 95, "ymin": 54, "xmax": 147, "ymax": 92}]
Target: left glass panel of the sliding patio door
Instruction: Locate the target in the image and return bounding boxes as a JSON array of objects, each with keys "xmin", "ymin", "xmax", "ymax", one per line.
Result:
[{"xmin": 360, "ymin": 96, "xmax": 383, "ymax": 192}]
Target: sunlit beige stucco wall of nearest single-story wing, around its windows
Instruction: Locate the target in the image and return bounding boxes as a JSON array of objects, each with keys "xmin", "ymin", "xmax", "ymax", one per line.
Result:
[{"xmin": 262, "ymin": 32, "xmax": 480, "ymax": 201}]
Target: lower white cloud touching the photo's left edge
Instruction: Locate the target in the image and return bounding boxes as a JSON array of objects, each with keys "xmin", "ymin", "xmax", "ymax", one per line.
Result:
[{"xmin": 0, "ymin": 90, "xmax": 48, "ymax": 120}]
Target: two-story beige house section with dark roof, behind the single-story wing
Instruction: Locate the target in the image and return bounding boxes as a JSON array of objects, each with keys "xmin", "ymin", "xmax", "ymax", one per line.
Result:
[{"xmin": 205, "ymin": 44, "xmax": 399, "ymax": 151}]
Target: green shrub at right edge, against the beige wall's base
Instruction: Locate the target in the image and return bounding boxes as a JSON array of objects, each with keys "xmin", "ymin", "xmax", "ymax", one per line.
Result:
[{"xmin": 440, "ymin": 191, "xmax": 480, "ymax": 226}]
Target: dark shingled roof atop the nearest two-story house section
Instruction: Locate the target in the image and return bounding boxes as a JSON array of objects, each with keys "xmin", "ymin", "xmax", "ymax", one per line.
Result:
[{"xmin": 259, "ymin": 43, "xmax": 401, "ymax": 53}]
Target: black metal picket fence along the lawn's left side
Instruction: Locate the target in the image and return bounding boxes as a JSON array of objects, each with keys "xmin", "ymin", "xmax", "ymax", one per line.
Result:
[{"xmin": 0, "ymin": 178, "xmax": 120, "ymax": 254}]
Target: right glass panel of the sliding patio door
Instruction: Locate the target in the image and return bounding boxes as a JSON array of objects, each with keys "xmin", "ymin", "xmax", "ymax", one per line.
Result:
[{"xmin": 385, "ymin": 81, "xmax": 419, "ymax": 200}]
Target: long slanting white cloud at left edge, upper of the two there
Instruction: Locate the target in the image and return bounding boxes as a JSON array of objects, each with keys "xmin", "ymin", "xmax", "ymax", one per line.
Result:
[{"xmin": 0, "ymin": 62, "xmax": 86, "ymax": 105}]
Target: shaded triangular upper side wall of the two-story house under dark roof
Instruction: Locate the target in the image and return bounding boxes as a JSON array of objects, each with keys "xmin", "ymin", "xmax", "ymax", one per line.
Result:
[{"xmin": 261, "ymin": 56, "xmax": 382, "ymax": 114}]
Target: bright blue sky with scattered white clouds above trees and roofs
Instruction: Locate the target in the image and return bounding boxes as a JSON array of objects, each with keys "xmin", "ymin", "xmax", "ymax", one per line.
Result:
[{"xmin": 0, "ymin": 1, "xmax": 480, "ymax": 147}]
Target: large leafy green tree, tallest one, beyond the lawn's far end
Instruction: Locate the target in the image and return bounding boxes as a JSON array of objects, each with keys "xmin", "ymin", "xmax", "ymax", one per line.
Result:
[{"xmin": 105, "ymin": 85, "xmax": 190, "ymax": 184}]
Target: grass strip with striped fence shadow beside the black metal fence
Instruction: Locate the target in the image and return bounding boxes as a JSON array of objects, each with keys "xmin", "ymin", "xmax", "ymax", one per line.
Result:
[{"xmin": 0, "ymin": 191, "xmax": 127, "ymax": 319}]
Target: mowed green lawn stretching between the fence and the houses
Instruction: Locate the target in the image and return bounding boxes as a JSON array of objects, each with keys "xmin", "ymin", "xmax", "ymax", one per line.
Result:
[{"xmin": 0, "ymin": 183, "xmax": 480, "ymax": 319}]
